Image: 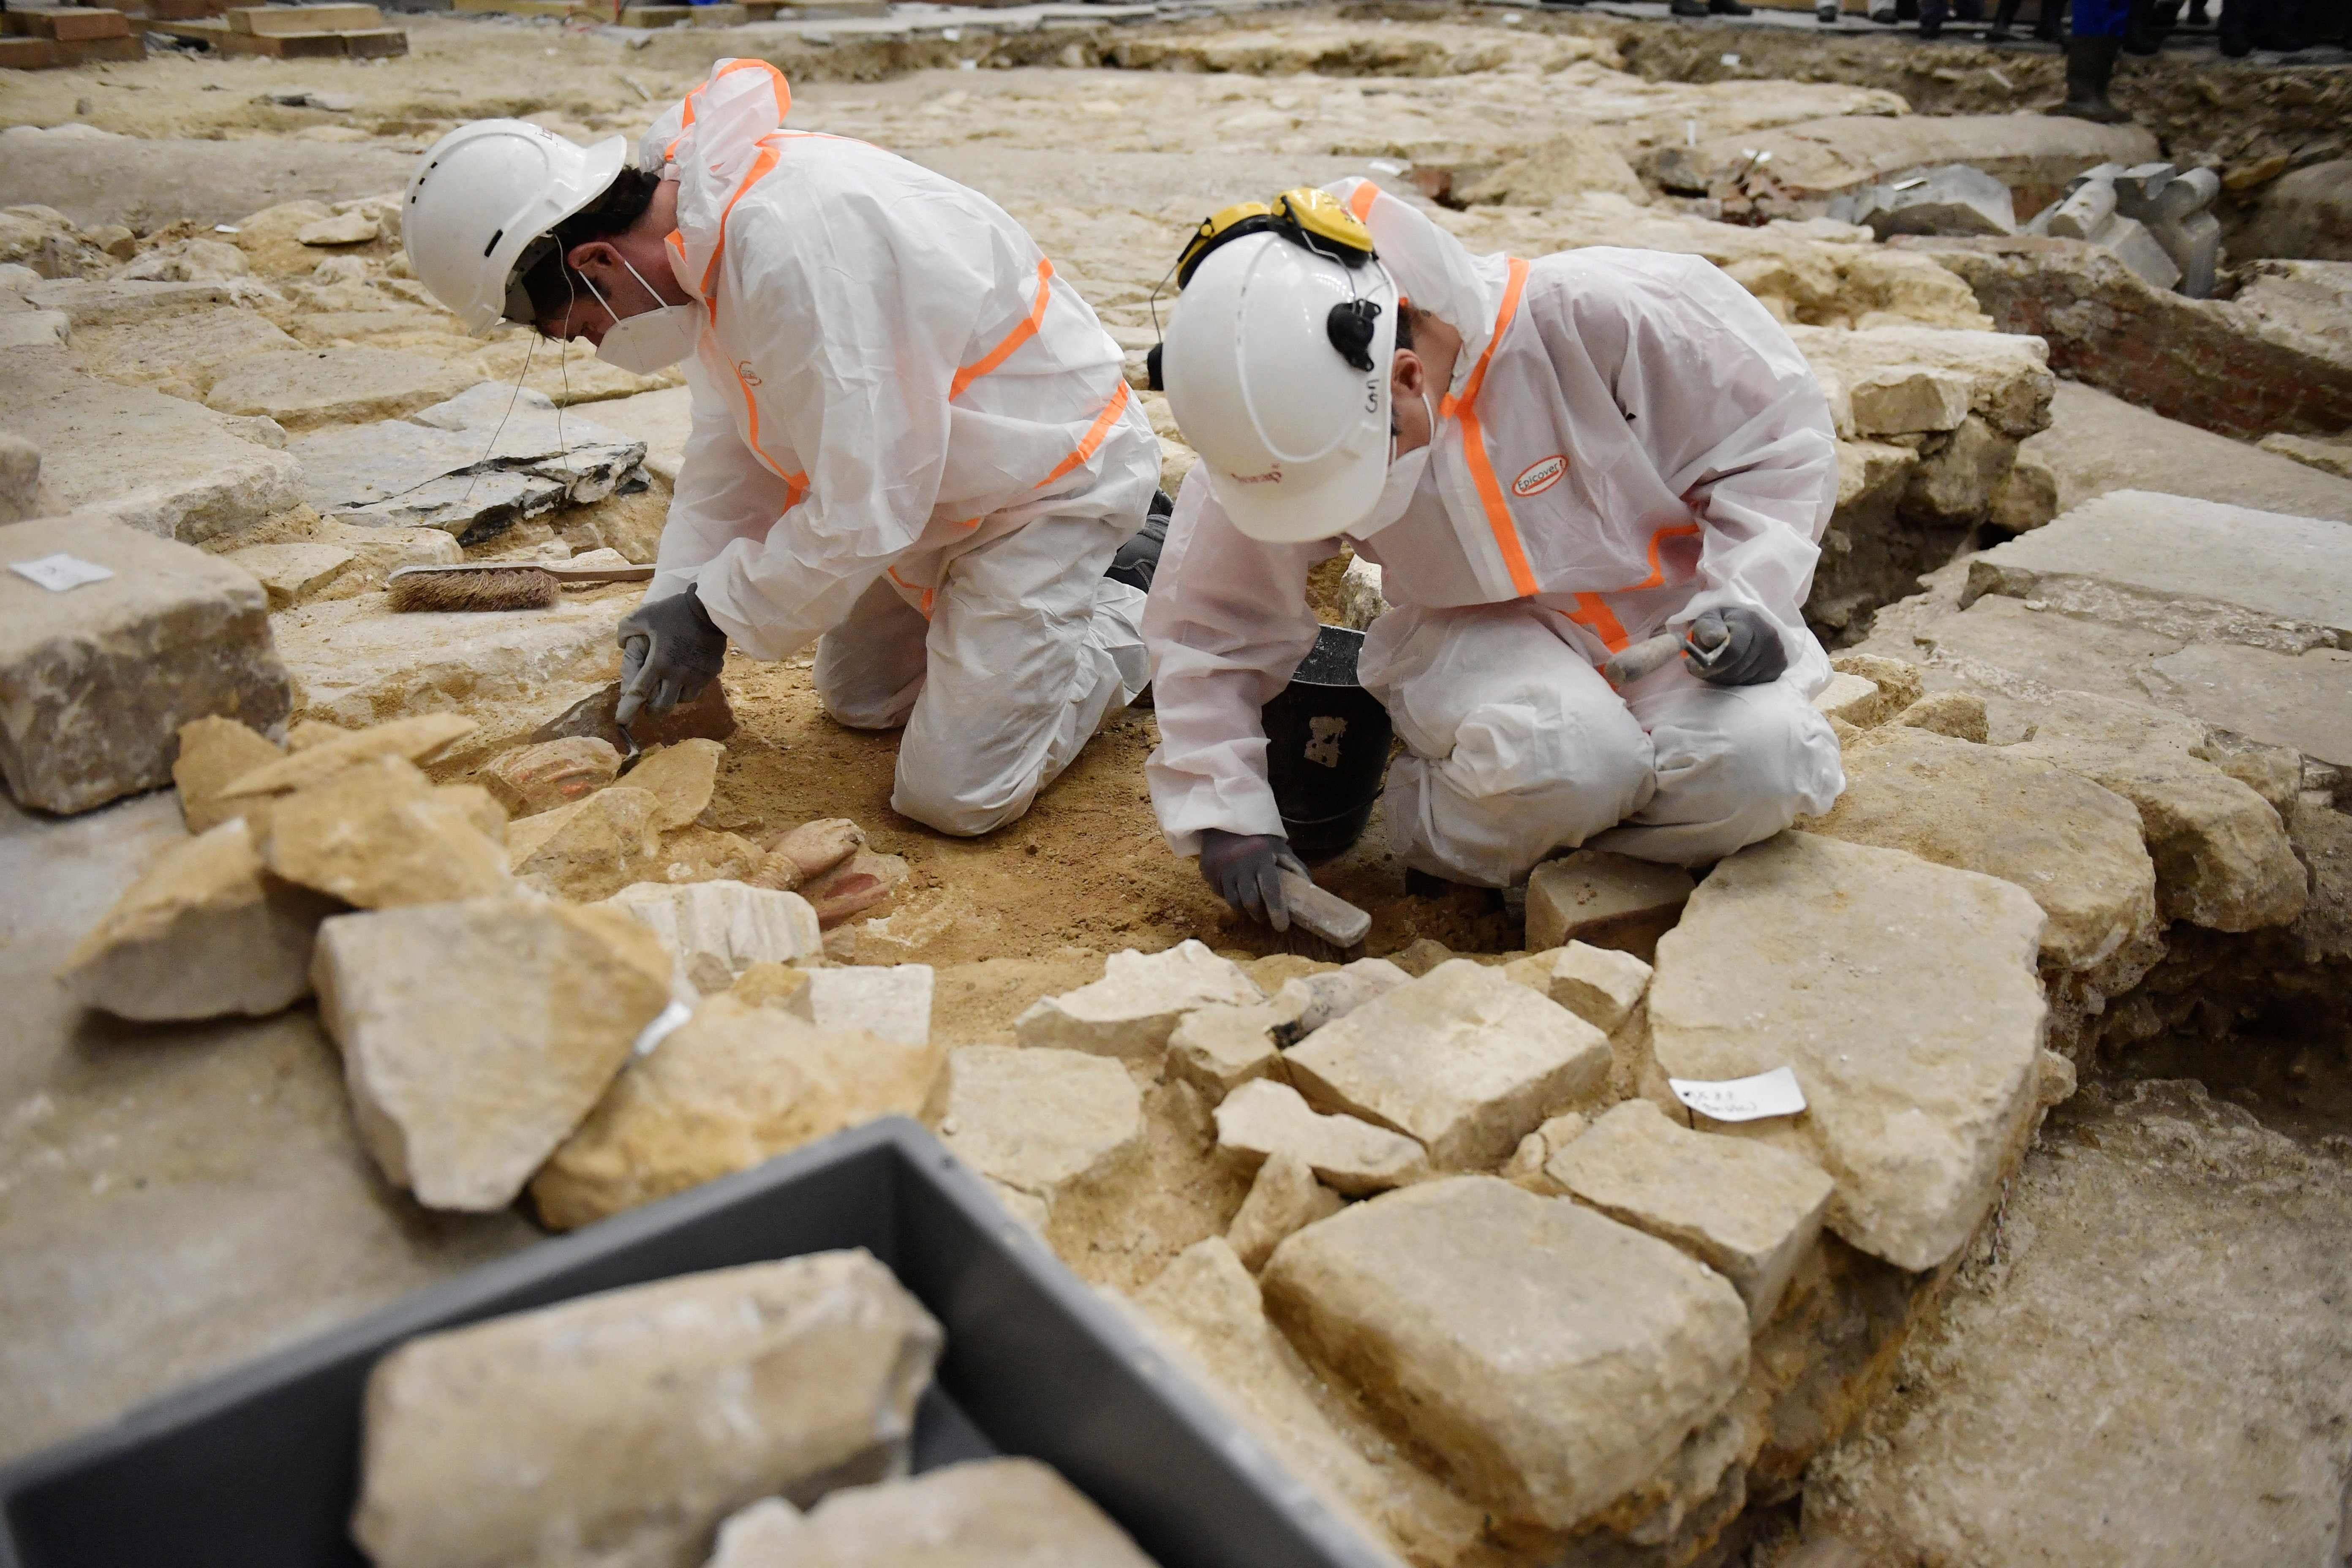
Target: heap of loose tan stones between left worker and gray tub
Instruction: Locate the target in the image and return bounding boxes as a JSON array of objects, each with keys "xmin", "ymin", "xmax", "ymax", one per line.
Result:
[{"xmin": 61, "ymin": 710, "xmax": 922, "ymax": 1227}]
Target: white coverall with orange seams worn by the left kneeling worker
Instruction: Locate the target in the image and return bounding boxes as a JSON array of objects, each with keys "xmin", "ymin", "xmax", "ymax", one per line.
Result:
[{"xmin": 640, "ymin": 59, "xmax": 1160, "ymax": 835}]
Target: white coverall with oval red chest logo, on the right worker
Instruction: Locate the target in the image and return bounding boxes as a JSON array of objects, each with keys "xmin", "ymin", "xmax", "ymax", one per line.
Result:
[{"xmin": 1143, "ymin": 179, "xmax": 1844, "ymax": 886}]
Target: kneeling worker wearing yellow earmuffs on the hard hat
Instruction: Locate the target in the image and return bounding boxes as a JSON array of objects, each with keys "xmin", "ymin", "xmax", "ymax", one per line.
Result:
[{"xmin": 1143, "ymin": 181, "xmax": 1844, "ymax": 926}]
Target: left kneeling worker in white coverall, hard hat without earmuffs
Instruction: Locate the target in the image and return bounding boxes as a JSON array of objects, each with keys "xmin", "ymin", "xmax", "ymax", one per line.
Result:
[{"xmin": 405, "ymin": 59, "xmax": 1160, "ymax": 835}]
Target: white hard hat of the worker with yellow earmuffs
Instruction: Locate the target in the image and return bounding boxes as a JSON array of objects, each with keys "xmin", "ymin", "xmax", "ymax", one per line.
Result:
[{"xmin": 1160, "ymin": 233, "xmax": 1397, "ymax": 543}]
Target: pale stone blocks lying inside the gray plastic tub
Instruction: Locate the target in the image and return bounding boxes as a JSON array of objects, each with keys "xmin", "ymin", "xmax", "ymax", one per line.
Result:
[{"xmin": 351, "ymin": 1251, "xmax": 1150, "ymax": 1568}]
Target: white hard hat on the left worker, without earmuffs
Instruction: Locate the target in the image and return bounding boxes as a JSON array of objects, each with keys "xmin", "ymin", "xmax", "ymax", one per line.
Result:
[{"xmin": 400, "ymin": 120, "xmax": 628, "ymax": 336}]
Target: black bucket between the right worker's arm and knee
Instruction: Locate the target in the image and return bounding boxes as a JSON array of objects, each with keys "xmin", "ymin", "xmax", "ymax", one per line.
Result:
[{"xmin": 1263, "ymin": 625, "xmax": 1392, "ymax": 865}]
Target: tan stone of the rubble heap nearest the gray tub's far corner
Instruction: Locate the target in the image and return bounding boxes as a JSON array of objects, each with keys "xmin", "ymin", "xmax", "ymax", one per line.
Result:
[{"xmin": 531, "ymin": 997, "xmax": 941, "ymax": 1230}]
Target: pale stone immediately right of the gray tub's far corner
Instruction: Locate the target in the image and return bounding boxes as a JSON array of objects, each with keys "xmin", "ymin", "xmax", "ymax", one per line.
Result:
[{"xmin": 939, "ymin": 1046, "xmax": 1143, "ymax": 1203}]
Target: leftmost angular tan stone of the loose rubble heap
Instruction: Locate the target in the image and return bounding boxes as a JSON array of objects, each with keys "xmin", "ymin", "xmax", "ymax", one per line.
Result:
[{"xmin": 59, "ymin": 820, "xmax": 341, "ymax": 1023}]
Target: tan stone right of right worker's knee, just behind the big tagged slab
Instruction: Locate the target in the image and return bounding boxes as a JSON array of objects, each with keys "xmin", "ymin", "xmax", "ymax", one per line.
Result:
[{"xmin": 1806, "ymin": 727, "xmax": 2157, "ymax": 985}]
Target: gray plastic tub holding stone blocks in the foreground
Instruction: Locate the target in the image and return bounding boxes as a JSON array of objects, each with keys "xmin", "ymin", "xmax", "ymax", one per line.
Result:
[{"xmin": 0, "ymin": 1116, "xmax": 1395, "ymax": 1568}]
